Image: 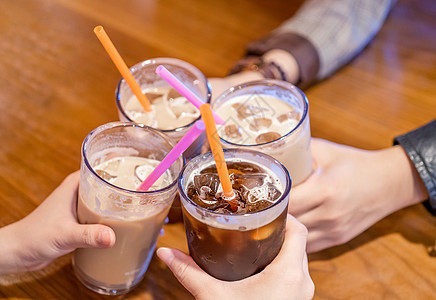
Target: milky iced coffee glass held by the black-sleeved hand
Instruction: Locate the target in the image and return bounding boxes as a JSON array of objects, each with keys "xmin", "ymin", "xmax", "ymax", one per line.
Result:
[{"xmin": 212, "ymin": 79, "xmax": 312, "ymax": 185}]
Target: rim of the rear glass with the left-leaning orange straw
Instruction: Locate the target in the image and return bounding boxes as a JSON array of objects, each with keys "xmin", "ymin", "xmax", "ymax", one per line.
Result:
[{"xmin": 115, "ymin": 57, "xmax": 212, "ymax": 133}]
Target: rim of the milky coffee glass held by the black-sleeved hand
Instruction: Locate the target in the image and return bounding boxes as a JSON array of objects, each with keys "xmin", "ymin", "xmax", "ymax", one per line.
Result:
[{"xmin": 212, "ymin": 79, "xmax": 309, "ymax": 148}]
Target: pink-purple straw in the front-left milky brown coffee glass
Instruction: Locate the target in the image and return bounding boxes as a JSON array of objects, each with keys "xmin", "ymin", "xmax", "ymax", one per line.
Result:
[{"xmin": 137, "ymin": 121, "xmax": 206, "ymax": 192}]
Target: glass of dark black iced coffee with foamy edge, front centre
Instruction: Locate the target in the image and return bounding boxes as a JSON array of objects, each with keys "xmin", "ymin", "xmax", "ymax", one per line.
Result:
[{"xmin": 178, "ymin": 149, "xmax": 291, "ymax": 281}]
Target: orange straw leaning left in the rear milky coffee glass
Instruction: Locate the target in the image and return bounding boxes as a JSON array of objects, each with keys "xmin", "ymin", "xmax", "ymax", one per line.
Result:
[{"xmin": 94, "ymin": 25, "xmax": 151, "ymax": 111}]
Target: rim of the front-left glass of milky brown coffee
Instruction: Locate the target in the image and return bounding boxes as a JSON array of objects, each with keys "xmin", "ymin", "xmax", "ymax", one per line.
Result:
[{"xmin": 81, "ymin": 121, "xmax": 184, "ymax": 195}]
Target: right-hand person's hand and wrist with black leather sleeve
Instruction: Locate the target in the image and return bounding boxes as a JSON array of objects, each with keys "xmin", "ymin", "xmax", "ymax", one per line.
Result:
[{"xmin": 289, "ymin": 121, "xmax": 436, "ymax": 252}]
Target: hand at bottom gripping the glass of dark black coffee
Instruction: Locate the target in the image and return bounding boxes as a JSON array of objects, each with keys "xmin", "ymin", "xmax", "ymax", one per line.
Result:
[{"xmin": 157, "ymin": 215, "xmax": 314, "ymax": 300}]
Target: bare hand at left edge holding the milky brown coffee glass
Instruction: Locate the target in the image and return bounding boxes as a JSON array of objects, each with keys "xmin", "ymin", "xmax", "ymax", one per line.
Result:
[{"xmin": 0, "ymin": 172, "xmax": 115, "ymax": 274}]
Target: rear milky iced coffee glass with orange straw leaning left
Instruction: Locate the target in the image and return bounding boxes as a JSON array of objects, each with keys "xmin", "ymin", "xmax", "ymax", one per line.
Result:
[{"xmin": 115, "ymin": 57, "xmax": 211, "ymax": 160}]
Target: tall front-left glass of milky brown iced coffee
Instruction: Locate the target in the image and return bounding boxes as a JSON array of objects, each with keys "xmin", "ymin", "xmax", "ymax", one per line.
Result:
[{"xmin": 73, "ymin": 122, "xmax": 183, "ymax": 295}]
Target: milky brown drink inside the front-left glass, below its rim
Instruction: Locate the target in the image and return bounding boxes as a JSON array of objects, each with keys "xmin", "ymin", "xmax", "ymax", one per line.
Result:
[{"xmin": 74, "ymin": 156, "xmax": 172, "ymax": 294}]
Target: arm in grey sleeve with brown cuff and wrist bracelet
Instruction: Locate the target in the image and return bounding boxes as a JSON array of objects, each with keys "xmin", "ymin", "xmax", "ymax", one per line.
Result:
[{"xmin": 211, "ymin": 0, "xmax": 396, "ymax": 96}]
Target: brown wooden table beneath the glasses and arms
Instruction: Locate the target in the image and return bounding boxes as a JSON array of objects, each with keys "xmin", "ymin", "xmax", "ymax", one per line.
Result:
[{"xmin": 0, "ymin": 0, "xmax": 436, "ymax": 299}]
